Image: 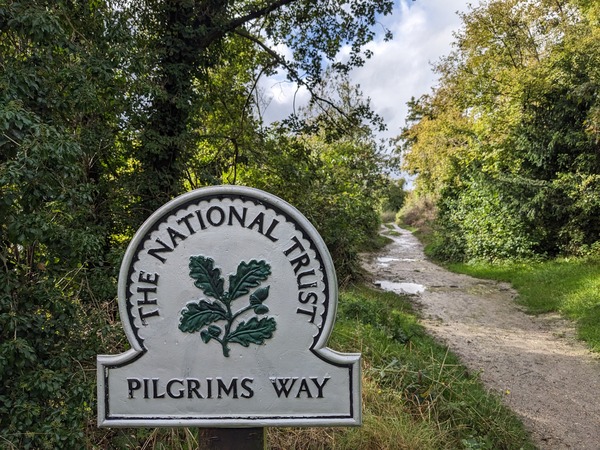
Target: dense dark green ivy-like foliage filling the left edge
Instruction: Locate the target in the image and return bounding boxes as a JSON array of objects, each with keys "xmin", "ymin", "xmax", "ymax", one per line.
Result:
[{"xmin": 0, "ymin": 1, "xmax": 127, "ymax": 448}]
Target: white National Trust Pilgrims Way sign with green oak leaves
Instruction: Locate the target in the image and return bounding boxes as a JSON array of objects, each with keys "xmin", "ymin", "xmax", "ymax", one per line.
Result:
[{"xmin": 97, "ymin": 186, "xmax": 361, "ymax": 427}]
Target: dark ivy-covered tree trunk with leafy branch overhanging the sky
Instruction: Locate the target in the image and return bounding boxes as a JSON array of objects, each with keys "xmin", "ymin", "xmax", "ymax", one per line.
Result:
[{"xmin": 123, "ymin": 0, "xmax": 393, "ymax": 221}]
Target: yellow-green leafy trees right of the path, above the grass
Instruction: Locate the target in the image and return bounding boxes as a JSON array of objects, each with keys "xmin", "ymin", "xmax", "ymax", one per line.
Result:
[{"xmin": 399, "ymin": 0, "xmax": 600, "ymax": 260}]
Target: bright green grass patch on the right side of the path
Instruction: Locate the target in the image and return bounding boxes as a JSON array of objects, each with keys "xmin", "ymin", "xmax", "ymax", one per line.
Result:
[{"xmin": 448, "ymin": 258, "xmax": 600, "ymax": 351}]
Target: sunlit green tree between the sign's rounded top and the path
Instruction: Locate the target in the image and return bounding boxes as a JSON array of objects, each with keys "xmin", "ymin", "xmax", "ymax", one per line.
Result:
[{"xmin": 238, "ymin": 72, "xmax": 386, "ymax": 280}]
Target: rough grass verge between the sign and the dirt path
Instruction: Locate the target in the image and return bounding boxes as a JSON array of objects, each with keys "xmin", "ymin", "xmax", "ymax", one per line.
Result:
[{"xmin": 268, "ymin": 286, "xmax": 534, "ymax": 450}]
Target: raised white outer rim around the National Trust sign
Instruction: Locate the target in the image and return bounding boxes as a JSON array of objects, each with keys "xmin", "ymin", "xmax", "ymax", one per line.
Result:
[{"xmin": 97, "ymin": 185, "xmax": 362, "ymax": 428}]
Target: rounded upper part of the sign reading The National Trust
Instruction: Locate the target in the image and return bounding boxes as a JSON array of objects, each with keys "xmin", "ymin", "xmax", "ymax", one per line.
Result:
[{"xmin": 119, "ymin": 186, "xmax": 337, "ymax": 357}]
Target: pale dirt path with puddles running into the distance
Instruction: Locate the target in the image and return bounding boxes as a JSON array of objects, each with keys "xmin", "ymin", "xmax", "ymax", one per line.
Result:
[{"xmin": 364, "ymin": 228, "xmax": 600, "ymax": 450}]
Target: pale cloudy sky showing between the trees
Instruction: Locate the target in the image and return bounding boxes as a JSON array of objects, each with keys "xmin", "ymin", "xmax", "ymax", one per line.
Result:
[{"xmin": 262, "ymin": 0, "xmax": 477, "ymax": 138}]
